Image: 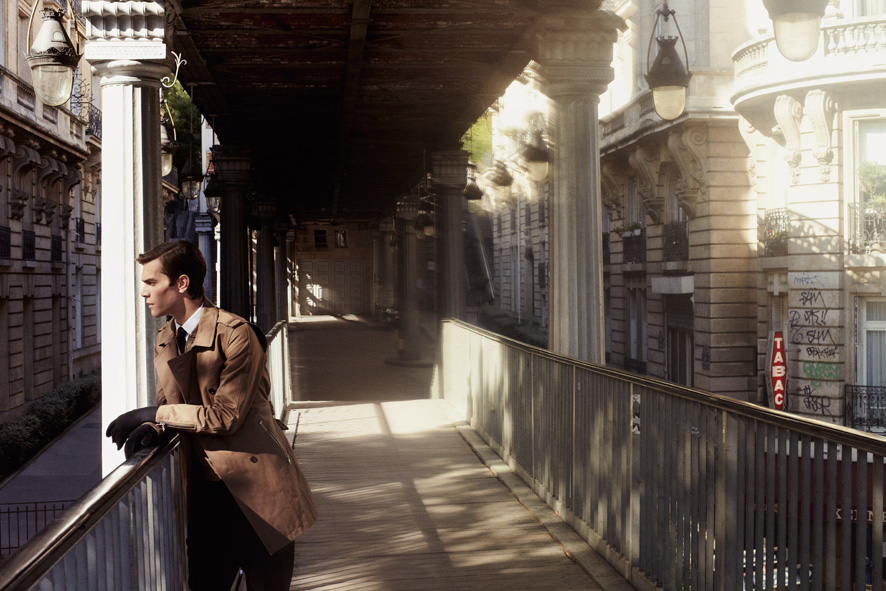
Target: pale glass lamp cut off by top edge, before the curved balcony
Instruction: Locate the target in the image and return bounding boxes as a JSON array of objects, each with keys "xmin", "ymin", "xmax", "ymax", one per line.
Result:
[{"xmin": 763, "ymin": 0, "xmax": 828, "ymax": 62}]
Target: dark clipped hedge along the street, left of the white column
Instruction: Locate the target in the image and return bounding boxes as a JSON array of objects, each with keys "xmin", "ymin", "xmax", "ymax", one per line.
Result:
[{"xmin": 0, "ymin": 375, "xmax": 101, "ymax": 479}]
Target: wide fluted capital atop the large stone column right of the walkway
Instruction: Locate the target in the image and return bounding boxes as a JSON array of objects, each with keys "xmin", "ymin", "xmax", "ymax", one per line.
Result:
[{"xmin": 537, "ymin": 10, "xmax": 625, "ymax": 100}]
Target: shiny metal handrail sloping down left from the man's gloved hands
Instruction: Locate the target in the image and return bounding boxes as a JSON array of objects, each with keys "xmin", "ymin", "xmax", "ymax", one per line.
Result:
[{"xmin": 0, "ymin": 435, "xmax": 180, "ymax": 591}]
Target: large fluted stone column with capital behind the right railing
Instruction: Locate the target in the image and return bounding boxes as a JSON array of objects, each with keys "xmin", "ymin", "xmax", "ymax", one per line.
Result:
[{"xmin": 538, "ymin": 11, "xmax": 621, "ymax": 364}]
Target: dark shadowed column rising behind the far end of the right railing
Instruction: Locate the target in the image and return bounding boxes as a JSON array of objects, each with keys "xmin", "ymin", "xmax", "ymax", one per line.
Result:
[{"xmin": 431, "ymin": 150, "xmax": 468, "ymax": 319}]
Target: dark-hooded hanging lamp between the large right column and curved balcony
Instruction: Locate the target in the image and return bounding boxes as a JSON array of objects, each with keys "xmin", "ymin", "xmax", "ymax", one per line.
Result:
[{"xmin": 646, "ymin": 2, "xmax": 692, "ymax": 121}]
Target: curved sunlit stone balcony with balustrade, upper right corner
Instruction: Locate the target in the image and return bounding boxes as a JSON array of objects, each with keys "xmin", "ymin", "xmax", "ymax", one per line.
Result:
[{"xmin": 732, "ymin": 15, "xmax": 886, "ymax": 115}]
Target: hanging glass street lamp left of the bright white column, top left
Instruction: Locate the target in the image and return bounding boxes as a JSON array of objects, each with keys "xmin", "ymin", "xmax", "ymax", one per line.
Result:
[{"xmin": 27, "ymin": 2, "xmax": 80, "ymax": 107}]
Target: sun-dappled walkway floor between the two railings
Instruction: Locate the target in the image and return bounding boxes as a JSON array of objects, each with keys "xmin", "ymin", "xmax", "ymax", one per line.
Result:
[{"xmin": 290, "ymin": 400, "xmax": 631, "ymax": 591}]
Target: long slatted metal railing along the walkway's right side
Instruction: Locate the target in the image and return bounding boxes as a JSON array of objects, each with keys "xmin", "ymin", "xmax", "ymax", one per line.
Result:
[{"xmin": 438, "ymin": 321, "xmax": 886, "ymax": 591}]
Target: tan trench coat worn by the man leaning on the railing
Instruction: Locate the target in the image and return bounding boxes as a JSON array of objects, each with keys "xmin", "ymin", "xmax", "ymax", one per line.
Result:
[{"xmin": 154, "ymin": 300, "xmax": 317, "ymax": 554}]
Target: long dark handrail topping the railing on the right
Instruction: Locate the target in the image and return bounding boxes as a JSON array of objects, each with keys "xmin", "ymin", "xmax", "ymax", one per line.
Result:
[{"xmin": 443, "ymin": 318, "xmax": 886, "ymax": 455}]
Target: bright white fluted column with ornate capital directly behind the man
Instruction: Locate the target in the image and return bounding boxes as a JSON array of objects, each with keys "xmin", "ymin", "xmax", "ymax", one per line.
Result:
[{"xmin": 82, "ymin": 0, "xmax": 170, "ymax": 474}]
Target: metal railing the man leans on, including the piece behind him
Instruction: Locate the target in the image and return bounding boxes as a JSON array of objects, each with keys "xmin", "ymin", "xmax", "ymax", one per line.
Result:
[{"xmin": 0, "ymin": 321, "xmax": 290, "ymax": 591}]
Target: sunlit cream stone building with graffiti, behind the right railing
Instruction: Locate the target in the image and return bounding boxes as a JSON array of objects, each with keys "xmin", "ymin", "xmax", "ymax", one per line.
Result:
[{"xmin": 485, "ymin": 0, "xmax": 886, "ymax": 430}]
